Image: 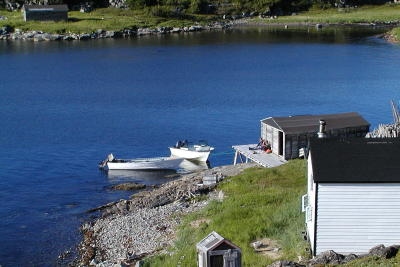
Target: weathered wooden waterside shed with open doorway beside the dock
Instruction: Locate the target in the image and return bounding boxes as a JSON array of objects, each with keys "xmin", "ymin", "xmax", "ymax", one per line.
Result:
[{"xmin": 261, "ymin": 112, "xmax": 370, "ymax": 160}]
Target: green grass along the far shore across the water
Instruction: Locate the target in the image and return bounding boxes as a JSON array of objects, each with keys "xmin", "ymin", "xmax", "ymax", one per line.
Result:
[{"xmin": 0, "ymin": 4, "xmax": 400, "ymax": 40}]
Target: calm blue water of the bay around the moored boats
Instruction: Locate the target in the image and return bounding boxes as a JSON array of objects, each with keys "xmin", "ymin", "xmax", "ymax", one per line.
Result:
[{"xmin": 0, "ymin": 28, "xmax": 400, "ymax": 267}]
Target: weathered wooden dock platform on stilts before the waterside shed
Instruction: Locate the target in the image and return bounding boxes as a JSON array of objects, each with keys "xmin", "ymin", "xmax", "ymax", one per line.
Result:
[{"xmin": 232, "ymin": 144, "xmax": 286, "ymax": 167}]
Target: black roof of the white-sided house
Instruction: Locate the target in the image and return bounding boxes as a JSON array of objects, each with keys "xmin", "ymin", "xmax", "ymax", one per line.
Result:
[{"xmin": 310, "ymin": 138, "xmax": 400, "ymax": 183}]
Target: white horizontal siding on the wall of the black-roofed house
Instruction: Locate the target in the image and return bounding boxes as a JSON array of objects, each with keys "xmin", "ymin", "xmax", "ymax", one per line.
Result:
[{"xmin": 309, "ymin": 184, "xmax": 400, "ymax": 255}]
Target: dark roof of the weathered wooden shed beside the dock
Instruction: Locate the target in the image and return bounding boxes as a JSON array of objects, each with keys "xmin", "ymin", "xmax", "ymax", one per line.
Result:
[{"xmin": 261, "ymin": 112, "xmax": 370, "ymax": 134}]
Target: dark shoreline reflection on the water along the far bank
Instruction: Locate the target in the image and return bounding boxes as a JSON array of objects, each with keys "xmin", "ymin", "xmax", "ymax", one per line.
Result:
[{"xmin": 0, "ymin": 25, "xmax": 391, "ymax": 56}]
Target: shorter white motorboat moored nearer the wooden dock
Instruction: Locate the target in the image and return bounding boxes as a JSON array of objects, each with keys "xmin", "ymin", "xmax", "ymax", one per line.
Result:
[{"xmin": 169, "ymin": 141, "xmax": 214, "ymax": 162}]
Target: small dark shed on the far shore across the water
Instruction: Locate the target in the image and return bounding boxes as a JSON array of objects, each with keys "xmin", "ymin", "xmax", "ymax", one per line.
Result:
[{"xmin": 22, "ymin": 5, "xmax": 68, "ymax": 21}]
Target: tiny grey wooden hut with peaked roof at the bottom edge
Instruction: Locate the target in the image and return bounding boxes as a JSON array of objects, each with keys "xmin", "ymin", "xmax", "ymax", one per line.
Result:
[{"xmin": 196, "ymin": 231, "xmax": 242, "ymax": 267}]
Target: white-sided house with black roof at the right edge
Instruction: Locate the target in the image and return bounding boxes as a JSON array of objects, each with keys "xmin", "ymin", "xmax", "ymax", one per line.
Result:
[{"xmin": 302, "ymin": 138, "xmax": 400, "ymax": 256}]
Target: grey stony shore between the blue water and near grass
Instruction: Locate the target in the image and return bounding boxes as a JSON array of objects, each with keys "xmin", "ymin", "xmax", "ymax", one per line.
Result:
[{"xmin": 74, "ymin": 163, "xmax": 255, "ymax": 266}]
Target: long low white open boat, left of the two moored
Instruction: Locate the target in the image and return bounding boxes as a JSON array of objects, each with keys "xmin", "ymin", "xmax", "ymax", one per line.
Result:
[{"xmin": 99, "ymin": 154, "xmax": 184, "ymax": 170}]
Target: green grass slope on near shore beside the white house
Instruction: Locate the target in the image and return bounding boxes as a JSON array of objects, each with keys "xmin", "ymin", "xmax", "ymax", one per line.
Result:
[{"xmin": 145, "ymin": 160, "xmax": 307, "ymax": 267}]
